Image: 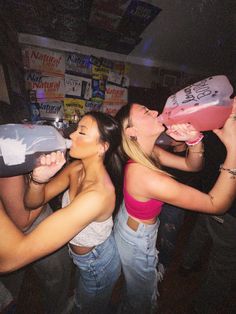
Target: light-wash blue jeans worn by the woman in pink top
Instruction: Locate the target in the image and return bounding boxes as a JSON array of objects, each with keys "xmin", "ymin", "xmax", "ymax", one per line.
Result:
[{"xmin": 114, "ymin": 203, "xmax": 159, "ymax": 314}]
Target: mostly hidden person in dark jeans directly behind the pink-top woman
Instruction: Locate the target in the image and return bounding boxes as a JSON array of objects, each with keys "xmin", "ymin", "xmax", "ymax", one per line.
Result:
[{"xmin": 157, "ymin": 139, "xmax": 204, "ymax": 281}]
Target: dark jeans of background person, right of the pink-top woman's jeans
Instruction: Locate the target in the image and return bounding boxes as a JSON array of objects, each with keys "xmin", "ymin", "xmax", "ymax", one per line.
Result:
[{"xmin": 158, "ymin": 204, "xmax": 185, "ymax": 267}]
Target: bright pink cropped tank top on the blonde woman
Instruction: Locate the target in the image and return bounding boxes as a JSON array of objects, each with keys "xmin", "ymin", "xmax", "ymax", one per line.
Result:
[{"xmin": 123, "ymin": 160, "xmax": 163, "ymax": 220}]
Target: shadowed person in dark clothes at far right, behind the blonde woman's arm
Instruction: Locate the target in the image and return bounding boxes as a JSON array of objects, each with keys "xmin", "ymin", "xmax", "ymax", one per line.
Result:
[{"xmin": 179, "ymin": 132, "xmax": 236, "ymax": 314}]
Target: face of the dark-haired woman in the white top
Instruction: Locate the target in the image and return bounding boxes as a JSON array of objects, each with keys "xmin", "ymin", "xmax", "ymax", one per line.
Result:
[{"xmin": 70, "ymin": 115, "xmax": 101, "ymax": 159}]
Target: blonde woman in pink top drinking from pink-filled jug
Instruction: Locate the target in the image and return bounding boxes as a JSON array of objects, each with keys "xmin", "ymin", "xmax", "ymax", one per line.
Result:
[{"xmin": 114, "ymin": 103, "xmax": 236, "ymax": 314}]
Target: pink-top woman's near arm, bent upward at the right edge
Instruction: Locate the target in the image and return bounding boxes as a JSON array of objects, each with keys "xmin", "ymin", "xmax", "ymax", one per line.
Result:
[{"xmin": 132, "ymin": 102, "xmax": 236, "ymax": 213}]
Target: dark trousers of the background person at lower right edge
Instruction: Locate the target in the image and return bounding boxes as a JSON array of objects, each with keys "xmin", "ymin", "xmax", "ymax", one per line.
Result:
[{"xmin": 183, "ymin": 214, "xmax": 236, "ymax": 314}]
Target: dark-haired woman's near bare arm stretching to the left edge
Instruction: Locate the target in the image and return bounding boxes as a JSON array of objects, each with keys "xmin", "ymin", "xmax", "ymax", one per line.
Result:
[{"xmin": 0, "ymin": 191, "xmax": 114, "ymax": 272}]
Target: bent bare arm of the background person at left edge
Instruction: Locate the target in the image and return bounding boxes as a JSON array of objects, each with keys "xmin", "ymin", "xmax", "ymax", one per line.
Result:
[{"xmin": 0, "ymin": 175, "xmax": 43, "ymax": 230}]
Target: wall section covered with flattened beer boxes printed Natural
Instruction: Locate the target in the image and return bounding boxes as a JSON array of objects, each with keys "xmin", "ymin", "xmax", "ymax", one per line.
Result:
[{"xmin": 22, "ymin": 45, "xmax": 129, "ymax": 122}]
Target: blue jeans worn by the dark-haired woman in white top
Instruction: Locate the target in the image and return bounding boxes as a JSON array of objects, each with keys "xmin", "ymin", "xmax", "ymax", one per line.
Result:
[{"xmin": 69, "ymin": 233, "xmax": 121, "ymax": 314}]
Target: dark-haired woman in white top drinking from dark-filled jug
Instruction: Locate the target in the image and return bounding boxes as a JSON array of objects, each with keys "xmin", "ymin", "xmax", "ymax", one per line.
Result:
[{"xmin": 0, "ymin": 112, "xmax": 121, "ymax": 313}]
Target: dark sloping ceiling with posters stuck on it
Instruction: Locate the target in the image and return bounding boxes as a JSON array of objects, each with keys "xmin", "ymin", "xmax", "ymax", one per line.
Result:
[{"xmin": 0, "ymin": 0, "xmax": 236, "ymax": 79}]
